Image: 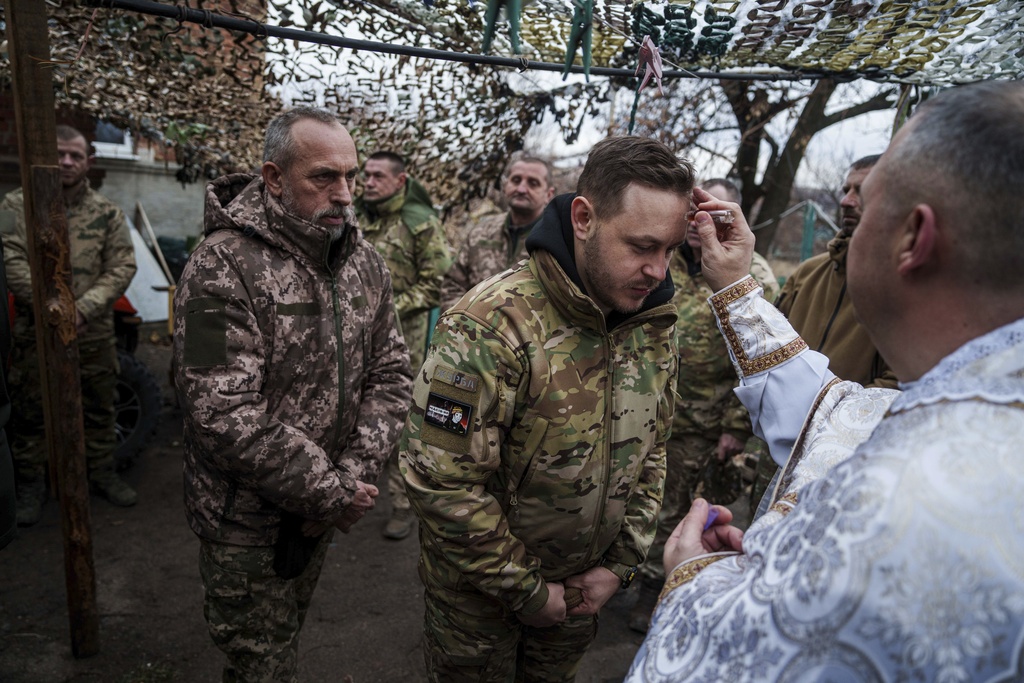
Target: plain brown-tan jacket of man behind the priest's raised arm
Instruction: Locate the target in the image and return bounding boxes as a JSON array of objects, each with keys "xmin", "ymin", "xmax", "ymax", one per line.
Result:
[{"xmin": 765, "ymin": 236, "xmax": 897, "ymax": 389}]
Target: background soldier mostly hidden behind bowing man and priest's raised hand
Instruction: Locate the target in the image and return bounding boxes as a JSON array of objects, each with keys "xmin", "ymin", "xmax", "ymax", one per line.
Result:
[{"xmin": 629, "ymin": 178, "xmax": 779, "ymax": 633}]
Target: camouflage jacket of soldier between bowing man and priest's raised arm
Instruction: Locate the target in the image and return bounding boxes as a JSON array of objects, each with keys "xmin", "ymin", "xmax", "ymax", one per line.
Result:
[{"xmin": 671, "ymin": 246, "xmax": 778, "ymax": 440}]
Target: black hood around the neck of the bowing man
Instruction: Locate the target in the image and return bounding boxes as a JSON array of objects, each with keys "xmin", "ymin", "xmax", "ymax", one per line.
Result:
[{"xmin": 526, "ymin": 193, "xmax": 676, "ymax": 330}]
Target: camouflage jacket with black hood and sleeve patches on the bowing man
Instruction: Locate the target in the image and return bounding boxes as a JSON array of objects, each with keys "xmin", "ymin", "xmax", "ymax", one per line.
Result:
[{"xmin": 399, "ymin": 196, "xmax": 676, "ymax": 613}]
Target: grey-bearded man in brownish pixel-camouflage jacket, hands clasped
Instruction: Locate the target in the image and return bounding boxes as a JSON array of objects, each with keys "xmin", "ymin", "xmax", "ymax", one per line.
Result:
[{"xmin": 173, "ymin": 108, "xmax": 412, "ymax": 681}]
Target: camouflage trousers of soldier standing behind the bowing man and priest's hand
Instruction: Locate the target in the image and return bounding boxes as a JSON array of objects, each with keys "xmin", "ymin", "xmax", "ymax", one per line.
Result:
[{"xmin": 639, "ymin": 434, "xmax": 716, "ymax": 583}]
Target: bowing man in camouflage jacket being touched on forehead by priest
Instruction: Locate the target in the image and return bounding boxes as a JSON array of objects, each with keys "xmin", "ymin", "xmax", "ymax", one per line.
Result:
[{"xmin": 400, "ymin": 137, "xmax": 693, "ymax": 683}]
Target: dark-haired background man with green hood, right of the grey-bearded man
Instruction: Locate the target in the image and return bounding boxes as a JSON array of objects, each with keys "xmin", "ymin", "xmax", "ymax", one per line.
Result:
[{"xmin": 355, "ymin": 152, "xmax": 452, "ymax": 540}]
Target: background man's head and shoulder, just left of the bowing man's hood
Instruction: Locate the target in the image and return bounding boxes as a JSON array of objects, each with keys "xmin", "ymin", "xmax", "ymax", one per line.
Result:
[{"xmin": 441, "ymin": 157, "xmax": 555, "ymax": 309}]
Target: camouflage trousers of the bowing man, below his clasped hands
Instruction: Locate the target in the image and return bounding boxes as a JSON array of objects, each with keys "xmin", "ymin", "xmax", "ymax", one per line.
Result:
[{"xmin": 420, "ymin": 561, "xmax": 597, "ymax": 683}]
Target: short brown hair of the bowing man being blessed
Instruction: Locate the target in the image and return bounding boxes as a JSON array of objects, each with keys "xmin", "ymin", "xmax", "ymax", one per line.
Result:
[{"xmin": 577, "ymin": 135, "xmax": 694, "ymax": 218}]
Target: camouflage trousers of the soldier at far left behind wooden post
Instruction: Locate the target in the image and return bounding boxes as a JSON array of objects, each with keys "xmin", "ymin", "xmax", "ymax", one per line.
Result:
[{"xmin": 7, "ymin": 339, "xmax": 119, "ymax": 481}]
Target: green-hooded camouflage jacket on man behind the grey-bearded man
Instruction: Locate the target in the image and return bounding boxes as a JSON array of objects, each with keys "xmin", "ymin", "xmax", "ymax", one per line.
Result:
[{"xmin": 356, "ymin": 178, "xmax": 452, "ymax": 371}]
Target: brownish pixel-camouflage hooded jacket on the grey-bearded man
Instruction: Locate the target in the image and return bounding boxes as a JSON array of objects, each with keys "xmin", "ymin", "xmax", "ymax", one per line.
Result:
[{"xmin": 173, "ymin": 174, "xmax": 412, "ymax": 546}]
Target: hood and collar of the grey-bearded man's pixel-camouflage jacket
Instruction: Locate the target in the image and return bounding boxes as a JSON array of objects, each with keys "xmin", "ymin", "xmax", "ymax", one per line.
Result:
[{"xmin": 204, "ymin": 173, "xmax": 359, "ymax": 263}]
